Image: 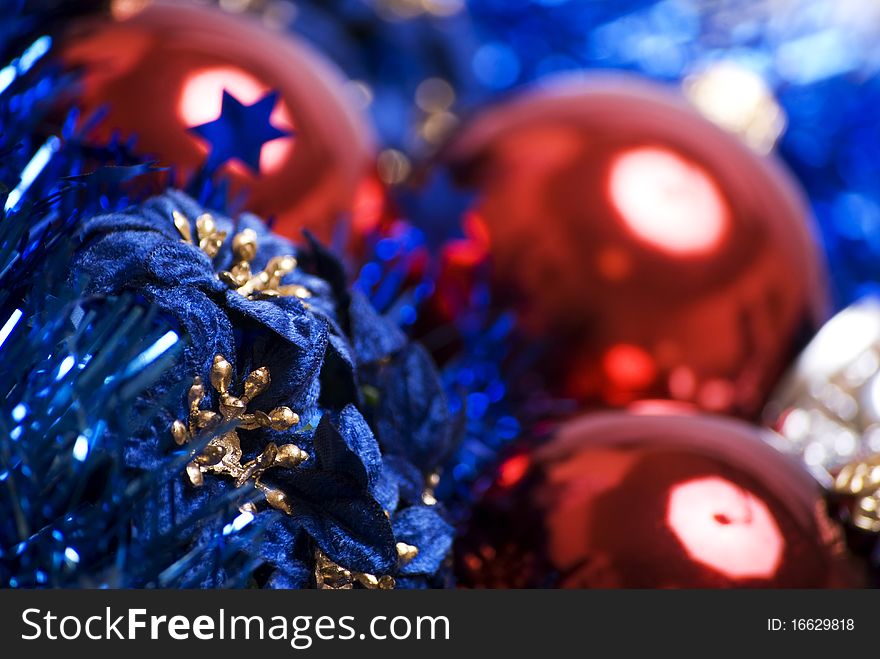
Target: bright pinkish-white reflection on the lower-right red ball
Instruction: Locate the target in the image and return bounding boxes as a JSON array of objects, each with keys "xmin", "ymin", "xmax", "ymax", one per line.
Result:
[{"xmin": 666, "ymin": 476, "xmax": 785, "ymax": 579}]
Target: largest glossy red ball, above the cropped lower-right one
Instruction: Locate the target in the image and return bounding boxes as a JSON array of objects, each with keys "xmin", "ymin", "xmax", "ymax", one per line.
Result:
[{"xmin": 440, "ymin": 76, "xmax": 827, "ymax": 416}]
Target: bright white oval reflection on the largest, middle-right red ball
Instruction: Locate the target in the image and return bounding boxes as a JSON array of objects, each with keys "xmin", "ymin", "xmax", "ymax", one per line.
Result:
[{"xmin": 608, "ymin": 146, "xmax": 730, "ymax": 256}]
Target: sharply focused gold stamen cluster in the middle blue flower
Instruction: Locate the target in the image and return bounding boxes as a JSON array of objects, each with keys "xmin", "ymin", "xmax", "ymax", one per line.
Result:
[{"xmin": 171, "ymin": 355, "xmax": 309, "ymax": 515}]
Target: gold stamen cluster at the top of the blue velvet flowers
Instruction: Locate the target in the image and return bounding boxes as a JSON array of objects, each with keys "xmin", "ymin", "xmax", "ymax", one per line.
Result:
[{"xmin": 171, "ymin": 211, "xmax": 312, "ymax": 300}]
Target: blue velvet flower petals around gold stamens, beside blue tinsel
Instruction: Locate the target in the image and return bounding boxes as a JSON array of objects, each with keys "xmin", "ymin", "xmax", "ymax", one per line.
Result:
[{"xmin": 72, "ymin": 191, "xmax": 455, "ymax": 588}]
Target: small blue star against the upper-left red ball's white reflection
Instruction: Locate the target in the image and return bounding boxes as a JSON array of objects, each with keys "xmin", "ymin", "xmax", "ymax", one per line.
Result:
[{"xmin": 188, "ymin": 89, "xmax": 293, "ymax": 174}]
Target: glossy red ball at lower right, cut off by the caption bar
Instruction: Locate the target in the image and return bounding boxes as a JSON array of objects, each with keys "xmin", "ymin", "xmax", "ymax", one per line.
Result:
[{"xmin": 456, "ymin": 412, "xmax": 865, "ymax": 588}]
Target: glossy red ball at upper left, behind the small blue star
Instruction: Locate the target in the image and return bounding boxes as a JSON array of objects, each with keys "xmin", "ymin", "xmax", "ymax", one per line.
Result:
[{"xmin": 63, "ymin": 2, "xmax": 373, "ymax": 239}]
